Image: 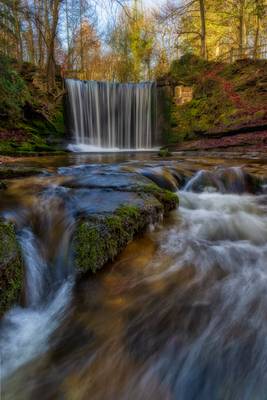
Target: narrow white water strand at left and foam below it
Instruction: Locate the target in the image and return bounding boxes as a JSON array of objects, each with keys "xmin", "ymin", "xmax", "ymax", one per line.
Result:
[{"xmin": 0, "ymin": 230, "xmax": 73, "ymax": 378}]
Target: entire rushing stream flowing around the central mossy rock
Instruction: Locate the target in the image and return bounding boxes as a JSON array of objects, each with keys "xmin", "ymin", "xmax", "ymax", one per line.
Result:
[{"xmin": 0, "ymin": 152, "xmax": 267, "ymax": 400}]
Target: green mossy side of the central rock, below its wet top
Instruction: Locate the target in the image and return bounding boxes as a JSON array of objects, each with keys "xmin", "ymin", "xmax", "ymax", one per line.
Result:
[{"xmin": 73, "ymin": 190, "xmax": 178, "ymax": 273}]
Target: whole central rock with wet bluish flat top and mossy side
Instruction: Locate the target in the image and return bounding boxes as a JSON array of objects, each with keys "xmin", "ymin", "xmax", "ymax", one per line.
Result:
[{"xmin": 64, "ymin": 167, "xmax": 178, "ymax": 273}]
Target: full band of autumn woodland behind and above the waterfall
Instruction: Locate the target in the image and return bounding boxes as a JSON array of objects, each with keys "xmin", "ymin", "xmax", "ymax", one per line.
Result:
[{"xmin": 0, "ymin": 0, "xmax": 267, "ymax": 86}]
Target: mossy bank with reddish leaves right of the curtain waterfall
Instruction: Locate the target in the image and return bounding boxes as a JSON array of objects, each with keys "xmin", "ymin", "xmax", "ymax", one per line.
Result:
[{"xmin": 165, "ymin": 56, "xmax": 267, "ymax": 143}]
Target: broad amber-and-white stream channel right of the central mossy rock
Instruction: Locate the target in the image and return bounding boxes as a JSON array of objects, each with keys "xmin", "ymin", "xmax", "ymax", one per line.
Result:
[{"xmin": 0, "ymin": 155, "xmax": 267, "ymax": 400}]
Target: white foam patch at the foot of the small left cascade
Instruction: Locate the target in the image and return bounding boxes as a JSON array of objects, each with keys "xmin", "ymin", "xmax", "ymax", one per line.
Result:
[{"xmin": 0, "ymin": 280, "xmax": 73, "ymax": 379}]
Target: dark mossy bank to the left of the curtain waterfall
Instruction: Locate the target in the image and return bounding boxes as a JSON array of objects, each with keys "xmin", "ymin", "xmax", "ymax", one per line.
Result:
[{"xmin": 0, "ymin": 56, "xmax": 64, "ymax": 154}]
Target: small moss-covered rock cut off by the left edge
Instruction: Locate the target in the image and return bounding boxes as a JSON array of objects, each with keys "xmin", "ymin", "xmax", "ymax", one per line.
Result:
[{"xmin": 0, "ymin": 221, "xmax": 24, "ymax": 316}]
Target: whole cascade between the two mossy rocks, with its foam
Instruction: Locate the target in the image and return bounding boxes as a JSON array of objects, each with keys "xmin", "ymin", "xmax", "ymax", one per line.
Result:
[{"xmin": 0, "ymin": 192, "xmax": 74, "ymax": 381}]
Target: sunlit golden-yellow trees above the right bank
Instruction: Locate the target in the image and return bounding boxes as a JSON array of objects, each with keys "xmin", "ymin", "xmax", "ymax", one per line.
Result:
[{"xmin": 157, "ymin": 0, "xmax": 267, "ymax": 59}]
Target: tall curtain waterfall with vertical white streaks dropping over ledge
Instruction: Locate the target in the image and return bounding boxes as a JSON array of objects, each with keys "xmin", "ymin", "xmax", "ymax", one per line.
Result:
[{"xmin": 66, "ymin": 79, "xmax": 156, "ymax": 150}]
